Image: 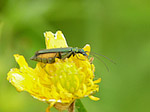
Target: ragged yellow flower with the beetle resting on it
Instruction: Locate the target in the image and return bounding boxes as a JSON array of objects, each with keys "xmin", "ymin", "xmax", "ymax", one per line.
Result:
[{"xmin": 7, "ymin": 31, "xmax": 101, "ymax": 112}]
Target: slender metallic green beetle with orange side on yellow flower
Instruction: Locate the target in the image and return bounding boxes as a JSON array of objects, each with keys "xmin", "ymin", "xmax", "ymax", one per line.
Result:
[{"xmin": 30, "ymin": 47, "xmax": 88, "ymax": 63}]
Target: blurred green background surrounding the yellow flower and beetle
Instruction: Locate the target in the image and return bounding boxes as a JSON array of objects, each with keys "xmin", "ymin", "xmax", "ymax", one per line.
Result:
[{"xmin": 0, "ymin": 0, "xmax": 150, "ymax": 112}]
